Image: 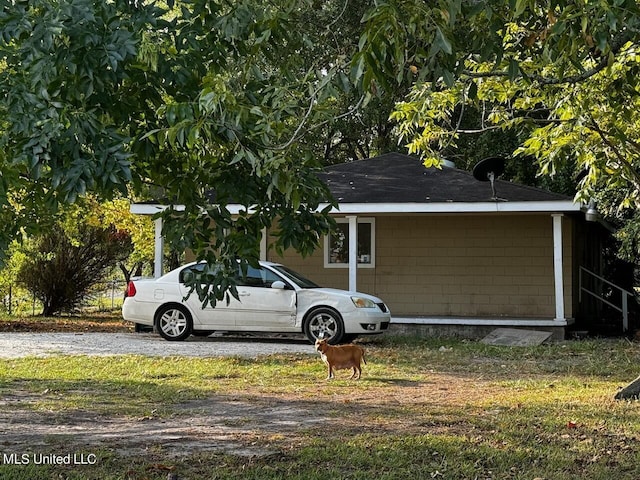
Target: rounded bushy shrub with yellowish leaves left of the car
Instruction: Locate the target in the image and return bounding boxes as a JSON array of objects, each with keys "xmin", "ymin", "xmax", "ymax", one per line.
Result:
[{"xmin": 0, "ymin": 196, "xmax": 154, "ymax": 315}]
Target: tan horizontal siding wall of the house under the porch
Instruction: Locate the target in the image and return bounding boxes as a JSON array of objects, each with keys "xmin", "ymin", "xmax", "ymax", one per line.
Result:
[{"xmin": 269, "ymin": 214, "xmax": 573, "ymax": 318}]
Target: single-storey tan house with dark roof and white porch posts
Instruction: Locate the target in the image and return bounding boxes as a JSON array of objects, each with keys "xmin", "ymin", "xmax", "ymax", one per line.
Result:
[{"xmin": 132, "ymin": 153, "xmax": 620, "ymax": 338}]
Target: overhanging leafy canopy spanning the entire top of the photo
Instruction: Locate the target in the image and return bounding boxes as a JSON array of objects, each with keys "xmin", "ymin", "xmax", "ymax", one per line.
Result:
[{"xmin": 0, "ymin": 0, "xmax": 640, "ymax": 308}]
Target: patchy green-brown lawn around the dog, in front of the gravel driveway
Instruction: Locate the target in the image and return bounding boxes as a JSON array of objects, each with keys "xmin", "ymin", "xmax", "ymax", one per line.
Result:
[{"xmin": 0, "ymin": 320, "xmax": 640, "ymax": 480}]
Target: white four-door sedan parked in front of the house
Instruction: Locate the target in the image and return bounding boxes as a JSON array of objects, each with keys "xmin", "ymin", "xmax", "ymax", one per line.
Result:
[{"xmin": 122, "ymin": 262, "xmax": 391, "ymax": 344}]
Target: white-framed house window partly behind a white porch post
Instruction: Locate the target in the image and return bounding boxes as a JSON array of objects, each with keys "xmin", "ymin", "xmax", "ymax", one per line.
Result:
[{"xmin": 324, "ymin": 218, "xmax": 375, "ymax": 268}]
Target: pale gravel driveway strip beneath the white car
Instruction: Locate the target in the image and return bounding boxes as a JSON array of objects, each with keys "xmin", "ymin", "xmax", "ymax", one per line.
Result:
[{"xmin": 0, "ymin": 333, "xmax": 314, "ymax": 358}]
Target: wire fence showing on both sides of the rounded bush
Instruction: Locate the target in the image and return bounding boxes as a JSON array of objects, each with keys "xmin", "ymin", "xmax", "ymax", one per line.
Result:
[{"xmin": 0, "ymin": 280, "xmax": 126, "ymax": 315}]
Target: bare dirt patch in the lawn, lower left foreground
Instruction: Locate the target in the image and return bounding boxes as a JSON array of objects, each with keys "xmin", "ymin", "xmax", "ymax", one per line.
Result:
[{"xmin": 0, "ymin": 397, "xmax": 326, "ymax": 458}]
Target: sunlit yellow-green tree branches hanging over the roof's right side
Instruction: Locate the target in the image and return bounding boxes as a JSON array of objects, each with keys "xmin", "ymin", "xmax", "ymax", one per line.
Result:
[{"xmin": 355, "ymin": 0, "xmax": 640, "ymax": 257}]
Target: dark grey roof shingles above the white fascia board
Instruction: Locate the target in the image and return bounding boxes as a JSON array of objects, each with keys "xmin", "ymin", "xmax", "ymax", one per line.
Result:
[{"xmin": 320, "ymin": 153, "xmax": 571, "ymax": 204}]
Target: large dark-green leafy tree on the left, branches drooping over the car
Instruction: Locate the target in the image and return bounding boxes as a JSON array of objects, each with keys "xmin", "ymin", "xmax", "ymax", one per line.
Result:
[{"xmin": 0, "ymin": 0, "xmax": 345, "ymax": 302}]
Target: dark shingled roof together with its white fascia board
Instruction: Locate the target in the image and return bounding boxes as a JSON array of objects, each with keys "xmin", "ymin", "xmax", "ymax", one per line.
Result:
[{"xmin": 132, "ymin": 153, "xmax": 581, "ymax": 214}]
